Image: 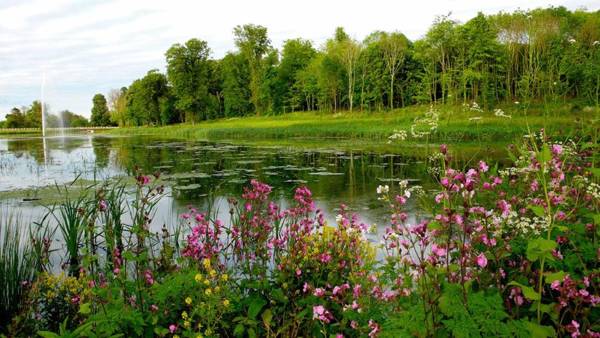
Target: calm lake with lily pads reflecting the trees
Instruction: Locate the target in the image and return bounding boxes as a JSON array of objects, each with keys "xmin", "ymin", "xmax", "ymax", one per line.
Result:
[{"xmin": 0, "ymin": 135, "xmax": 503, "ymax": 232}]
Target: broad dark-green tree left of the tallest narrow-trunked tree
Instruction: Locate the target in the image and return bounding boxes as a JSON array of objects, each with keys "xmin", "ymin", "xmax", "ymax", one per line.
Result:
[{"xmin": 165, "ymin": 39, "xmax": 211, "ymax": 121}]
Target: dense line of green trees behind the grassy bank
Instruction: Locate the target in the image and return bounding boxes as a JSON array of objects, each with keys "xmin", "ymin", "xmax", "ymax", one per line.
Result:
[{"xmin": 5, "ymin": 7, "xmax": 600, "ymax": 126}]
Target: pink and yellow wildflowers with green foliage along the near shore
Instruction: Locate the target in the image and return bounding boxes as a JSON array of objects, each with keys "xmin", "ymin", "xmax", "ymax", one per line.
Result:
[{"xmin": 2, "ymin": 133, "xmax": 600, "ymax": 337}]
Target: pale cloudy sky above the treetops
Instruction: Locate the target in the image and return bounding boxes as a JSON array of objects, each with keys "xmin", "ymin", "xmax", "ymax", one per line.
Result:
[{"xmin": 0, "ymin": 0, "xmax": 600, "ymax": 119}]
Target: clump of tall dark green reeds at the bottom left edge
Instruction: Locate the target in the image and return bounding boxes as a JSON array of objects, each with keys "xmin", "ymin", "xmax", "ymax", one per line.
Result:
[{"xmin": 0, "ymin": 210, "xmax": 39, "ymax": 332}]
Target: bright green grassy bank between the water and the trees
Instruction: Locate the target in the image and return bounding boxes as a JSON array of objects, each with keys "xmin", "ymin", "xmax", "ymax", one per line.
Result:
[{"xmin": 109, "ymin": 104, "xmax": 600, "ymax": 142}]
